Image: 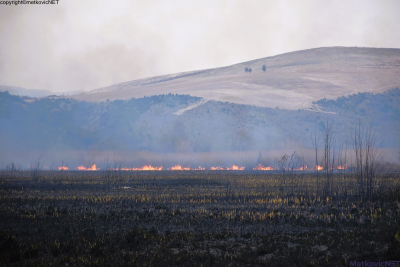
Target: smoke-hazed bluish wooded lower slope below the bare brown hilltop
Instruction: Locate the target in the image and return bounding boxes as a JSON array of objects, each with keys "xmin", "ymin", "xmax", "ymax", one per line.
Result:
[{"xmin": 0, "ymin": 89, "xmax": 400, "ymax": 153}]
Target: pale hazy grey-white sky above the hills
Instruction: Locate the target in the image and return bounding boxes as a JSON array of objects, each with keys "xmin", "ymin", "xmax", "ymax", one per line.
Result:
[{"xmin": 0, "ymin": 0, "xmax": 400, "ymax": 91}]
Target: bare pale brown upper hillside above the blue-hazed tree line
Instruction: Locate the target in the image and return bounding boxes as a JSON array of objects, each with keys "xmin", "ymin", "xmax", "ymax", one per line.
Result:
[{"xmin": 72, "ymin": 47, "xmax": 400, "ymax": 109}]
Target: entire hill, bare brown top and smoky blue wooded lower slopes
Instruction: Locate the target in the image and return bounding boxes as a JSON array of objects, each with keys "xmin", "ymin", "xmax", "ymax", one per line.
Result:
[{"xmin": 0, "ymin": 47, "xmax": 400, "ymax": 167}]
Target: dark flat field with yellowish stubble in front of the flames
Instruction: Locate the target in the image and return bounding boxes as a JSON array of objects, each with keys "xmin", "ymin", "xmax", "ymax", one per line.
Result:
[{"xmin": 0, "ymin": 171, "xmax": 400, "ymax": 266}]
